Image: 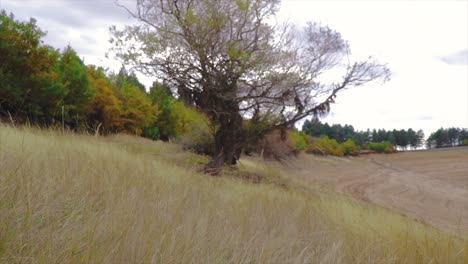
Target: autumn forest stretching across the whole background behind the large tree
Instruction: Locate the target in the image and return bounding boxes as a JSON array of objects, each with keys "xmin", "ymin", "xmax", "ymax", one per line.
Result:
[{"xmin": 0, "ymin": 11, "xmax": 468, "ymax": 161}]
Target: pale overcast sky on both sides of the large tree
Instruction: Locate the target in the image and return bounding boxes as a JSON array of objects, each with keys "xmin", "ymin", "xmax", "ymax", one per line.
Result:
[{"xmin": 0, "ymin": 0, "xmax": 468, "ymax": 136}]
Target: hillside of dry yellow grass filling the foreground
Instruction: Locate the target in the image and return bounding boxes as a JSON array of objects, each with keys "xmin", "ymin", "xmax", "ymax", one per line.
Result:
[{"xmin": 0, "ymin": 124, "xmax": 468, "ymax": 263}]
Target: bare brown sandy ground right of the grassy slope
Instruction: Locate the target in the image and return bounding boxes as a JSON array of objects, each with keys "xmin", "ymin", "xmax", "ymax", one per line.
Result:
[{"xmin": 287, "ymin": 147, "xmax": 468, "ymax": 235}]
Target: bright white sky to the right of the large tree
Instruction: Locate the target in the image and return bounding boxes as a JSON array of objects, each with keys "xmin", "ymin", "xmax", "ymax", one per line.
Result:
[{"xmin": 280, "ymin": 0, "xmax": 468, "ymax": 134}]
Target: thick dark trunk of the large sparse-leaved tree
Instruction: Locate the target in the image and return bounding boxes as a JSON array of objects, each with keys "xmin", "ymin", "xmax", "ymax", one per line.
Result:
[{"xmin": 205, "ymin": 103, "xmax": 244, "ymax": 175}]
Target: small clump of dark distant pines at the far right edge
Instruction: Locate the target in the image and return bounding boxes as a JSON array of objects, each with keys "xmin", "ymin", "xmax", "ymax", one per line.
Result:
[{"xmin": 426, "ymin": 127, "xmax": 468, "ymax": 148}]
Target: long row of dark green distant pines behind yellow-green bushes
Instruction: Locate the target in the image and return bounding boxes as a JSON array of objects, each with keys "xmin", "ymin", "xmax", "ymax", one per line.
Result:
[{"xmin": 302, "ymin": 119, "xmax": 424, "ymax": 149}]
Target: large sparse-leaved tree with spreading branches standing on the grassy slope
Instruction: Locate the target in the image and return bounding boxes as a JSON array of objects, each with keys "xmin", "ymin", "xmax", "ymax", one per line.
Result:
[{"xmin": 111, "ymin": 0, "xmax": 389, "ymax": 172}]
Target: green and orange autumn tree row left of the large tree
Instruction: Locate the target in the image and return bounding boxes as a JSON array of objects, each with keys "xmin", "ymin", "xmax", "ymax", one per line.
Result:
[{"xmin": 0, "ymin": 11, "xmax": 204, "ymax": 140}]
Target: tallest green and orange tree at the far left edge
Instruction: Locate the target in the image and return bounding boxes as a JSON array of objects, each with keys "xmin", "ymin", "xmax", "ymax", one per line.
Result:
[{"xmin": 0, "ymin": 10, "xmax": 62, "ymax": 122}]
